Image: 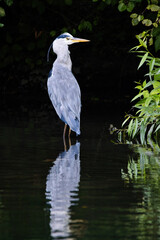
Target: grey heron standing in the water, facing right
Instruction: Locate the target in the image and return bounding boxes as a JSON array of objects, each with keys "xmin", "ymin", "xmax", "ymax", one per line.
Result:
[{"xmin": 47, "ymin": 33, "xmax": 90, "ymax": 138}]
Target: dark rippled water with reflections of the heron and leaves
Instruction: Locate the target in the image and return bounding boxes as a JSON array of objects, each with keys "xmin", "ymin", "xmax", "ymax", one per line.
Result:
[{"xmin": 0, "ymin": 111, "xmax": 160, "ymax": 240}]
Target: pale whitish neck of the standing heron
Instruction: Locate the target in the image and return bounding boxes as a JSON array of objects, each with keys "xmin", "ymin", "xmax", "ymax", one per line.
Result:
[{"xmin": 56, "ymin": 45, "xmax": 72, "ymax": 71}]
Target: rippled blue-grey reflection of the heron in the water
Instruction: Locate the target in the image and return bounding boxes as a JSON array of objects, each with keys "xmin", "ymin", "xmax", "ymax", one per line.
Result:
[{"xmin": 46, "ymin": 142, "xmax": 80, "ymax": 238}]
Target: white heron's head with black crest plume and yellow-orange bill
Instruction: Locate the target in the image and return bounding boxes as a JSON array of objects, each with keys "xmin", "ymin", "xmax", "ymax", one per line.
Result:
[{"xmin": 47, "ymin": 33, "xmax": 90, "ymax": 60}]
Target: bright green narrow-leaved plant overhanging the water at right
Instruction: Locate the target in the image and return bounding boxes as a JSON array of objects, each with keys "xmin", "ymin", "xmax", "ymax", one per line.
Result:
[{"xmin": 122, "ymin": 33, "xmax": 160, "ymax": 144}]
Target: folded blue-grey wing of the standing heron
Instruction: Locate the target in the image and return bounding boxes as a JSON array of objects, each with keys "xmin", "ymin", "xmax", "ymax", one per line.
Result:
[{"xmin": 48, "ymin": 64, "xmax": 81, "ymax": 130}]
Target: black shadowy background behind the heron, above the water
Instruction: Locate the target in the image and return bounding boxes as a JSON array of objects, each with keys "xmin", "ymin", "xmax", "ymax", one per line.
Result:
[{"xmin": 0, "ymin": 0, "xmax": 141, "ymax": 112}]
